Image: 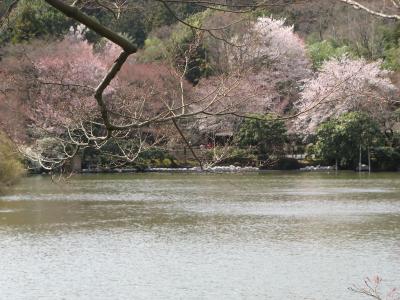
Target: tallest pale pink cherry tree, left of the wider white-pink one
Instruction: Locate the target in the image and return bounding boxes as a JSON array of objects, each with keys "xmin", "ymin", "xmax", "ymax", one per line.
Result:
[{"xmin": 230, "ymin": 17, "xmax": 311, "ymax": 114}]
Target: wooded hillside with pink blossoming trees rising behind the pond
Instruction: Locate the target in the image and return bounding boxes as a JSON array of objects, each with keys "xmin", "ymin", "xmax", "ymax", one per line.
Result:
[{"xmin": 0, "ymin": 0, "xmax": 400, "ymax": 170}]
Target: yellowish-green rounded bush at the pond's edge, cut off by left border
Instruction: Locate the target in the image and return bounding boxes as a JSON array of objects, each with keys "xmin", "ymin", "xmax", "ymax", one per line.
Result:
[{"xmin": 0, "ymin": 133, "xmax": 25, "ymax": 187}]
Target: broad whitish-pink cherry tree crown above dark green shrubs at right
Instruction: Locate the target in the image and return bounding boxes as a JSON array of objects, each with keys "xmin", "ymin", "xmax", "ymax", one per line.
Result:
[{"xmin": 295, "ymin": 56, "xmax": 397, "ymax": 133}]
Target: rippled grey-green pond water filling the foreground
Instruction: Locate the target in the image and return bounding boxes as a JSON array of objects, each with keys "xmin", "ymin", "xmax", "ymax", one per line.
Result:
[{"xmin": 0, "ymin": 172, "xmax": 400, "ymax": 300}]
